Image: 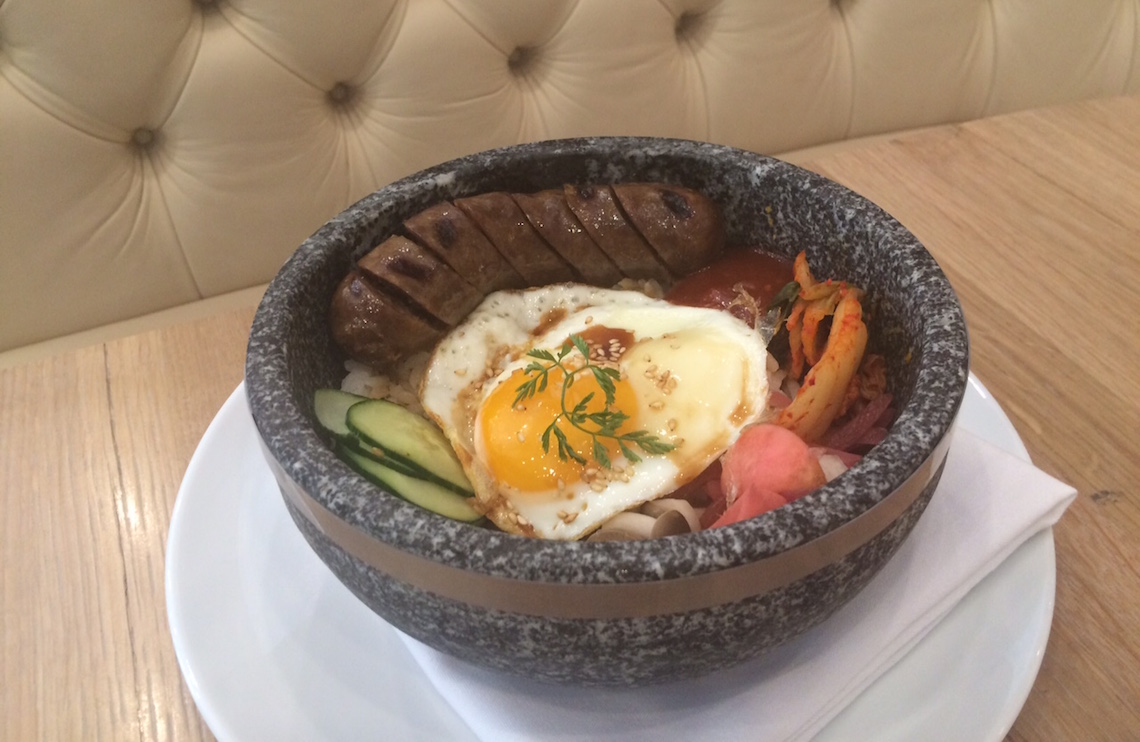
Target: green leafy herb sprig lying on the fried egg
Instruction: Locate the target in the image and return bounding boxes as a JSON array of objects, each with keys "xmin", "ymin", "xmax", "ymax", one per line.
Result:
[{"xmin": 511, "ymin": 335, "xmax": 675, "ymax": 468}]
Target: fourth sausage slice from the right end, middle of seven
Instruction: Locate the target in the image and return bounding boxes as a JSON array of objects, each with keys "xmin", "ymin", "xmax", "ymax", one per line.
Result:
[{"xmin": 455, "ymin": 191, "xmax": 578, "ymax": 286}]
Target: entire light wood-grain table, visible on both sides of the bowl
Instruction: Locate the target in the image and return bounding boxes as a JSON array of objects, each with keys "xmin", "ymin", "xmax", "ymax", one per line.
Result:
[{"xmin": 0, "ymin": 98, "xmax": 1140, "ymax": 741}]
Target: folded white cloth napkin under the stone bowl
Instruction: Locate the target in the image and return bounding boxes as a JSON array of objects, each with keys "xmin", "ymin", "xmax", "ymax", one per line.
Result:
[{"xmin": 400, "ymin": 429, "xmax": 1076, "ymax": 742}]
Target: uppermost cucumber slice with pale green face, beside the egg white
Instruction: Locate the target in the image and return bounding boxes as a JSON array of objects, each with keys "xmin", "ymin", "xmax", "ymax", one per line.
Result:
[{"xmin": 344, "ymin": 399, "xmax": 472, "ymax": 492}]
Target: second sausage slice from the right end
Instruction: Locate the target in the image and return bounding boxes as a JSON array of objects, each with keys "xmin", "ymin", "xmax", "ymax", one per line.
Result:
[{"xmin": 563, "ymin": 186, "xmax": 671, "ymax": 284}]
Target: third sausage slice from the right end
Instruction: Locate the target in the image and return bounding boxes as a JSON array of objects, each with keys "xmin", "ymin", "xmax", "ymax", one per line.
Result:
[{"xmin": 511, "ymin": 189, "xmax": 624, "ymax": 286}]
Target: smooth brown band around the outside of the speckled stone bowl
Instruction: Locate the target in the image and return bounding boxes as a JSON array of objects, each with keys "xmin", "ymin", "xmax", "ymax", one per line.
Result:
[{"xmin": 267, "ymin": 435, "xmax": 950, "ymax": 619}]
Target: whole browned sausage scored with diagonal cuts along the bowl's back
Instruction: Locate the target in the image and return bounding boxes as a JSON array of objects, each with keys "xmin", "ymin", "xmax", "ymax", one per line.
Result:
[{"xmin": 329, "ymin": 184, "xmax": 725, "ymax": 372}]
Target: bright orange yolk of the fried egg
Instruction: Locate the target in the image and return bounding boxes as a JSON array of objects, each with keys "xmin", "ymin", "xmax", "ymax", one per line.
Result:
[{"xmin": 479, "ymin": 368, "xmax": 638, "ymax": 492}]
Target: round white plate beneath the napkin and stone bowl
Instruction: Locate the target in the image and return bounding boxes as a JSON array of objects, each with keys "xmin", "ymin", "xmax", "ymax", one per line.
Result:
[{"xmin": 166, "ymin": 376, "xmax": 1056, "ymax": 742}]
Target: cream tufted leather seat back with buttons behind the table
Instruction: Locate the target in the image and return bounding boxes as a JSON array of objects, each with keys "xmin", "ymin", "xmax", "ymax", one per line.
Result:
[{"xmin": 0, "ymin": 0, "xmax": 1140, "ymax": 351}]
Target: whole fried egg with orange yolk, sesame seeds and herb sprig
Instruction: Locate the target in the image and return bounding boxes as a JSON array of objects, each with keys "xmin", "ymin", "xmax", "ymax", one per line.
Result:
[{"xmin": 421, "ymin": 284, "xmax": 768, "ymax": 539}]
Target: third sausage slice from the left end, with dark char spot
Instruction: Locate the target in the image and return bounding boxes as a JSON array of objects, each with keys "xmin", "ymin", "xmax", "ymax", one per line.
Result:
[{"xmin": 404, "ymin": 201, "xmax": 526, "ymax": 294}]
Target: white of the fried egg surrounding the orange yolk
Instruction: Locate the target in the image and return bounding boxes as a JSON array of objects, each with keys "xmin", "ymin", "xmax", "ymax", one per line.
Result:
[{"xmin": 421, "ymin": 284, "xmax": 768, "ymax": 539}]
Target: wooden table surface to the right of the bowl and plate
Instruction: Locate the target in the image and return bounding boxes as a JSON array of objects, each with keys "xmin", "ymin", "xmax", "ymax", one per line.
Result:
[{"xmin": 808, "ymin": 98, "xmax": 1140, "ymax": 742}]
